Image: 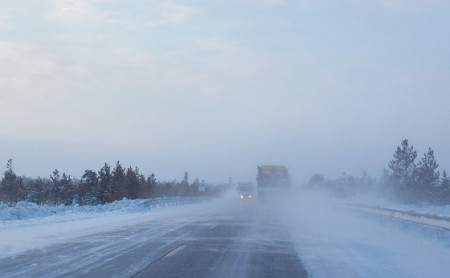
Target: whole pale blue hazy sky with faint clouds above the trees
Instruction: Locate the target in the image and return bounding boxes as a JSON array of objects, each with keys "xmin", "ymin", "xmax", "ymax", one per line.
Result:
[{"xmin": 0, "ymin": 0, "xmax": 450, "ymax": 183}]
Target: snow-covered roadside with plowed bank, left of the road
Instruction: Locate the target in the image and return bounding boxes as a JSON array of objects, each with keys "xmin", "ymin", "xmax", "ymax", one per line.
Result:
[{"xmin": 0, "ymin": 199, "xmax": 217, "ymax": 257}]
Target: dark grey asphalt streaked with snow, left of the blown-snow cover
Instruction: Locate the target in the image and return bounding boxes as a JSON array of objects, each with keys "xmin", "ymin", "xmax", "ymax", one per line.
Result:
[{"xmin": 0, "ymin": 202, "xmax": 308, "ymax": 278}]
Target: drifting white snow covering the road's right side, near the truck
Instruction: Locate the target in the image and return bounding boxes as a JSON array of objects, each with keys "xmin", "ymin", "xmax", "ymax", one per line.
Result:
[{"xmin": 281, "ymin": 191, "xmax": 450, "ymax": 278}]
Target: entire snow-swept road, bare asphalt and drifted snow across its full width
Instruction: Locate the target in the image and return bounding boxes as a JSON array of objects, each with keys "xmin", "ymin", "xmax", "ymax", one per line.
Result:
[{"xmin": 0, "ymin": 192, "xmax": 450, "ymax": 278}]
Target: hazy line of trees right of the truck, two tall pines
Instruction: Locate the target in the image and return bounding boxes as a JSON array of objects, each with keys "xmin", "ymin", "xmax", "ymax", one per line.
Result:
[{"xmin": 308, "ymin": 139, "xmax": 450, "ymax": 205}]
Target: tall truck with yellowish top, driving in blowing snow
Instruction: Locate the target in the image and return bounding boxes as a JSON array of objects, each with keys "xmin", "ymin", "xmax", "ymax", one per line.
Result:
[{"xmin": 256, "ymin": 165, "xmax": 291, "ymax": 199}]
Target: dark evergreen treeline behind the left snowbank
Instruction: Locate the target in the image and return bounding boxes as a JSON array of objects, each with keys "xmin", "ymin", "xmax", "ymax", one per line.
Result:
[{"xmin": 0, "ymin": 159, "xmax": 226, "ymax": 206}]
